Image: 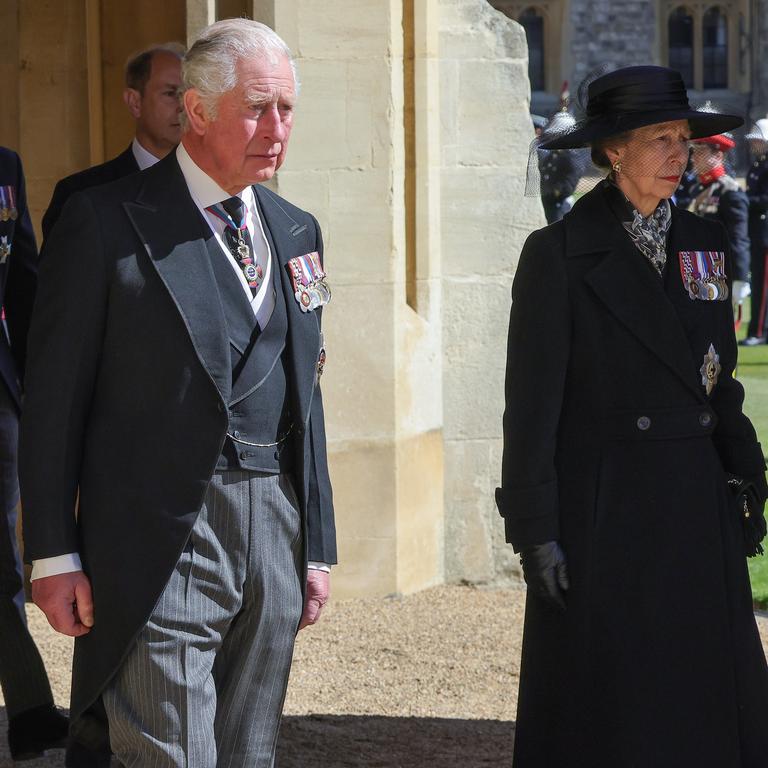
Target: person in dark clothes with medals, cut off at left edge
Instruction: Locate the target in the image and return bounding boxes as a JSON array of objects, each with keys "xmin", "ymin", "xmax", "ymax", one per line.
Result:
[{"xmin": 0, "ymin": 147, "xmax": 67, "ymax": 760}]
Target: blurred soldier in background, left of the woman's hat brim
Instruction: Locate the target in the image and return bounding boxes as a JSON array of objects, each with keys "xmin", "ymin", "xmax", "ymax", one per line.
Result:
[{"xmin": 538, "ymin": 110, "xmax": 582, "ymax": 224}]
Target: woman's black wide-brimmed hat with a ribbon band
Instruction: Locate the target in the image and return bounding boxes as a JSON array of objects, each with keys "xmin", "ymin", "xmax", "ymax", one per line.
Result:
[{"xmin": 539, "ymin": 66, "xmax": 744, "ymax": 149}]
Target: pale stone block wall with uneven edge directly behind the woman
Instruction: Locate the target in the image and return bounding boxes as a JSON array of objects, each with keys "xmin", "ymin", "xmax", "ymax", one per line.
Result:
[{"xmin": 440, "ymin": 0, "xmax": 545, "ymax": 582}]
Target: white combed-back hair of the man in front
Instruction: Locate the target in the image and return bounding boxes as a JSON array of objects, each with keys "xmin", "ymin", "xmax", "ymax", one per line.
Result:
[{"xmin": 181, "ymin": 19, "xmax": 299, "ymax": 126}]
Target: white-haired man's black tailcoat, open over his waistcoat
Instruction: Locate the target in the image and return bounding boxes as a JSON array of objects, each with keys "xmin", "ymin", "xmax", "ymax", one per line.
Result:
[{"xmin": 20, "ymin": 152, "xmax": 336, "ymax": 743}]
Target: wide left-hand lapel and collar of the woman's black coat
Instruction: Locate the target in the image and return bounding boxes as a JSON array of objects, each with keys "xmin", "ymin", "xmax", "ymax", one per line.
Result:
[{"xmin": 568, "ymin": 189, "xmax": 704, "ymax": 400}]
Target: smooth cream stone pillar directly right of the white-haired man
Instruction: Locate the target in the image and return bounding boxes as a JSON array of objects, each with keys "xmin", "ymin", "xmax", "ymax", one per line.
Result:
[{"xmin": 262, "ymin": 0, "xmax": 443, "ymax": 596}]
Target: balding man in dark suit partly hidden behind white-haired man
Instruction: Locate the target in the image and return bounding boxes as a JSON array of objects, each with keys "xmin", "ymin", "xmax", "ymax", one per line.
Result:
[{"xmin": 42, "ymin": 43, "xmax": 184, "ymax": 240}]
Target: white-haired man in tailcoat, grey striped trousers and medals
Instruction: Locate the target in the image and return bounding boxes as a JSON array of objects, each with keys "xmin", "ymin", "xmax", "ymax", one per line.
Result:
[{"xmin": 21, "ymin": 19, "xmax": 336, "ymax": 768}]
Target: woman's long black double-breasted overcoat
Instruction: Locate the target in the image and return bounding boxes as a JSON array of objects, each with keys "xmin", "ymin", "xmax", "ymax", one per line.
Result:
[{"xmin": 497, "ymin": 184, "xmax": 768, "ymax": 768}]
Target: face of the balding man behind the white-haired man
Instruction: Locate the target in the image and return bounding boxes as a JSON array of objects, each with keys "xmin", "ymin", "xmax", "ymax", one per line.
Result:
[{"xmin": 126, "ymin": 52, "xmax": 181, "ymax": 157}]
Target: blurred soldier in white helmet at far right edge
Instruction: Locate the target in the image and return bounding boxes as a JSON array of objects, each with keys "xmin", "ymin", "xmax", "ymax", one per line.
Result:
[{"xmin": 739, "ymin": 118, "xmax": 768, "ymax": 347}]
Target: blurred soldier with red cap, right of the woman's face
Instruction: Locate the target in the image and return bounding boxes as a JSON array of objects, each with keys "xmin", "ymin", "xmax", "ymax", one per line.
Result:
[{"xmin": 690, "ymin": 133, "xmax": 750, "ymax": 317}]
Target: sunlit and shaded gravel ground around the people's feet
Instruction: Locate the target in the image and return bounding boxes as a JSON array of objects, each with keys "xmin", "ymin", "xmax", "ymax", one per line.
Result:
[{"xmin": 0, "ymin": 587, "xmax": 768, "ymax": 768}]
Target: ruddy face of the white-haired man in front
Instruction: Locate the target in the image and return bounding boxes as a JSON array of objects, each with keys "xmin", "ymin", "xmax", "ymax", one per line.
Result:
[{"xmin": 196, "ymin": 55, "xmax": 296, "ymax": 191}]
